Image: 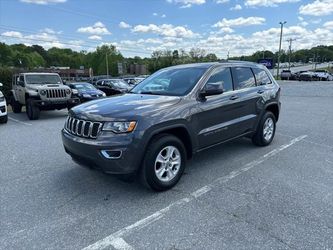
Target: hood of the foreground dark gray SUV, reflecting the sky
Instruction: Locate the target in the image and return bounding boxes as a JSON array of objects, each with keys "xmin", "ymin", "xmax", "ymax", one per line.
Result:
[{"xmin": 70, "ymin": 94, "xmax": 181, "ymax": 121}]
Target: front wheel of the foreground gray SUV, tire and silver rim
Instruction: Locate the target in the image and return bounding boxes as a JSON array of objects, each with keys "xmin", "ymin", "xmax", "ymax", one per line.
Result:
[{"xmin": 141, "ymin": 134, "xmax": 186, "ymax": 191}]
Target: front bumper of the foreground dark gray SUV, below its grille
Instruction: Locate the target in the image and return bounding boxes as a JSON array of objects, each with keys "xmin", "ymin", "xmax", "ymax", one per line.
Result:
[{"xmin": 62, "ymin": 129, "xmax": 142, "ymax": 174}]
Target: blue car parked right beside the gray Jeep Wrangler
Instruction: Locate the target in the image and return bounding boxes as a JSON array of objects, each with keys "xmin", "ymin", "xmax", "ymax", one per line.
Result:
[{"xmin": 68, "ymin": 82, "xmax": 106, "ymax": 103}]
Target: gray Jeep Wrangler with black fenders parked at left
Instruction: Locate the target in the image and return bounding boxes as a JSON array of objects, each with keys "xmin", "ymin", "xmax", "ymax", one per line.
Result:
[{"xmin": 10, "ymin": 73, "xmax": 80, "ymax": 120}]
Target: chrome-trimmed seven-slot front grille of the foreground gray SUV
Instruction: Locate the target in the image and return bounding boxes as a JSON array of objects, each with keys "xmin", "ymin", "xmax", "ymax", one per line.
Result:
[{"xmin": 65, "ymin": 116, "xmax": 103, "ymax": 139}]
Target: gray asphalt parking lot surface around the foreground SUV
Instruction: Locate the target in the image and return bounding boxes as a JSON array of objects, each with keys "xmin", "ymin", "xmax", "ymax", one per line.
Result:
[{"xmin": 0, "ymin": 81, "xmax": 333, "ymax": 249}]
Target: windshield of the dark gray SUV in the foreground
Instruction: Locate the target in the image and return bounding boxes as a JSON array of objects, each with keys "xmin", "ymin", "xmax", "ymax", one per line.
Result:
[{"xmin": 131, "ymin": 67, "xmax": 207, "ymax": 96}]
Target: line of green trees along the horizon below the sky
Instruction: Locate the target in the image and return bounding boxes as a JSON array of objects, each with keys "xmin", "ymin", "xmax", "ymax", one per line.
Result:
[{"xmin": 0, "ymin": 43, "xmax": 333, "ymax": 76}]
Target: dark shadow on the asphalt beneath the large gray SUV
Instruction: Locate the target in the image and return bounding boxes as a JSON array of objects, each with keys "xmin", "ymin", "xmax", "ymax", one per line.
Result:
[{"xmin": 54, "ymin": 138, "xmax": 260, "ymax": 199}]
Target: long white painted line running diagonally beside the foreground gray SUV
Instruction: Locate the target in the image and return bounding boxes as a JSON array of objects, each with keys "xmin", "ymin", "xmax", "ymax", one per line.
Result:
[{"xmin": 83, "ymin": 135, "xmax": 307, "ymax": 250}]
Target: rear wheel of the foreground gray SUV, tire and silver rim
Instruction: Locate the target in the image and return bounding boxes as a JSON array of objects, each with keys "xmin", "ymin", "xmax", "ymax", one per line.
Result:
[{"xmin": 252, "ymin": 111, "xmax": 276, "ymax": 146}]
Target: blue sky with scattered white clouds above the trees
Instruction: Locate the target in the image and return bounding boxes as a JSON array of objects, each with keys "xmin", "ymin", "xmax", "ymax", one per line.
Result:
[{"xmin": 0, "ymin": 0, "xmax": 333, "ymax": 58}]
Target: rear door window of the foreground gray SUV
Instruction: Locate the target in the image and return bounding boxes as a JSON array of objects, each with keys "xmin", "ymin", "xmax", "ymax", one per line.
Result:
[{"xmin": 232, "ymin": 67, "xmax": 256, "ymax": 90}]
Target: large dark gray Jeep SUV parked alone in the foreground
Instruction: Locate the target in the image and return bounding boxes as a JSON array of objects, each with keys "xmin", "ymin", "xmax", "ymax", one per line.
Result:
[{"xmin": 62, "ymin": 62, "xmax": 280, "ymax": 191}]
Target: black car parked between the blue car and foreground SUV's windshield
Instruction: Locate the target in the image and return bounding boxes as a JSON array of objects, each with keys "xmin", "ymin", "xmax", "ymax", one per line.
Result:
[{"xmin": 95, "ymin": 79, "xmax": 131, "ymax": 96}]
